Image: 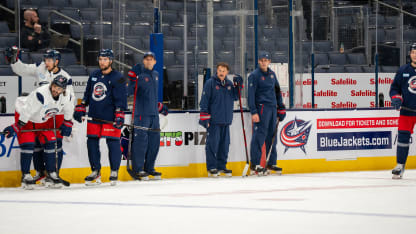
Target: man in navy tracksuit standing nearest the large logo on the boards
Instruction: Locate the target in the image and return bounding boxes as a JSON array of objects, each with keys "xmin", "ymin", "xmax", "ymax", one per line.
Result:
[{"xmin": 248, "ymin": 52, "xmax": 286, "ymax": 175}]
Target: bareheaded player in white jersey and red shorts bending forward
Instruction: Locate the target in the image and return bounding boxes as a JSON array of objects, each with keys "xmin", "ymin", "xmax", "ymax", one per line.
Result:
[{"xmin": 4, "ymin": 76, "xmax": 74, "ymax": 189}]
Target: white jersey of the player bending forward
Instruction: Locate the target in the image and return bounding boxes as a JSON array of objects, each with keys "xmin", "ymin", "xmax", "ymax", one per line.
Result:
[{"xmin": 15, "ymin": 85, "xmax": 74, "ymax": 123}]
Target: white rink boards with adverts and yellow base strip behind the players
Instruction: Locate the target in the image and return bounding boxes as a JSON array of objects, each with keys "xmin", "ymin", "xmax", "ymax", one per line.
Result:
[{"xmin": 0, "ymin": 109, "xmax": 416, "ymax": 187}]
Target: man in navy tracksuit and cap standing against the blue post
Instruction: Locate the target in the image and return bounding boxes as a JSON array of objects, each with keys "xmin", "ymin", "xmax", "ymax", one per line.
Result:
[{"xmin": 128, "ymin": 52, "xmax": 168, "ymax": 180}]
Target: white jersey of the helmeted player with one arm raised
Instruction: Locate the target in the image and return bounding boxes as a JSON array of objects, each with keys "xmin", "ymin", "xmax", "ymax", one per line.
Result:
[{"xmin": 10, "ymin": 59, "xmax": 75, "ymax": 98}]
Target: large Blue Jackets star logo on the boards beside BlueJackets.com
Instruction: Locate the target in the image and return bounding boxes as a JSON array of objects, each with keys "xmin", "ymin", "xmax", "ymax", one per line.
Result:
[{"xmin": 280, "ymin": 117, "xmax": 312, "ymax": 154}]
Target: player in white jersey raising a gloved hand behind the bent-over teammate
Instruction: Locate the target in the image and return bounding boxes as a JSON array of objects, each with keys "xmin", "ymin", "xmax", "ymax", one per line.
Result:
[{"xmin": 6, "ymin": 46, "xmax": 75, "ymax": 183}]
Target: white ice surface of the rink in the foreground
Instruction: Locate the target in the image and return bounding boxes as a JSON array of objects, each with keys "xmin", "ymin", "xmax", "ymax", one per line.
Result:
[{"xmin": 0, "ymin": 170, "xmax": 416, "ymax": 234}]
